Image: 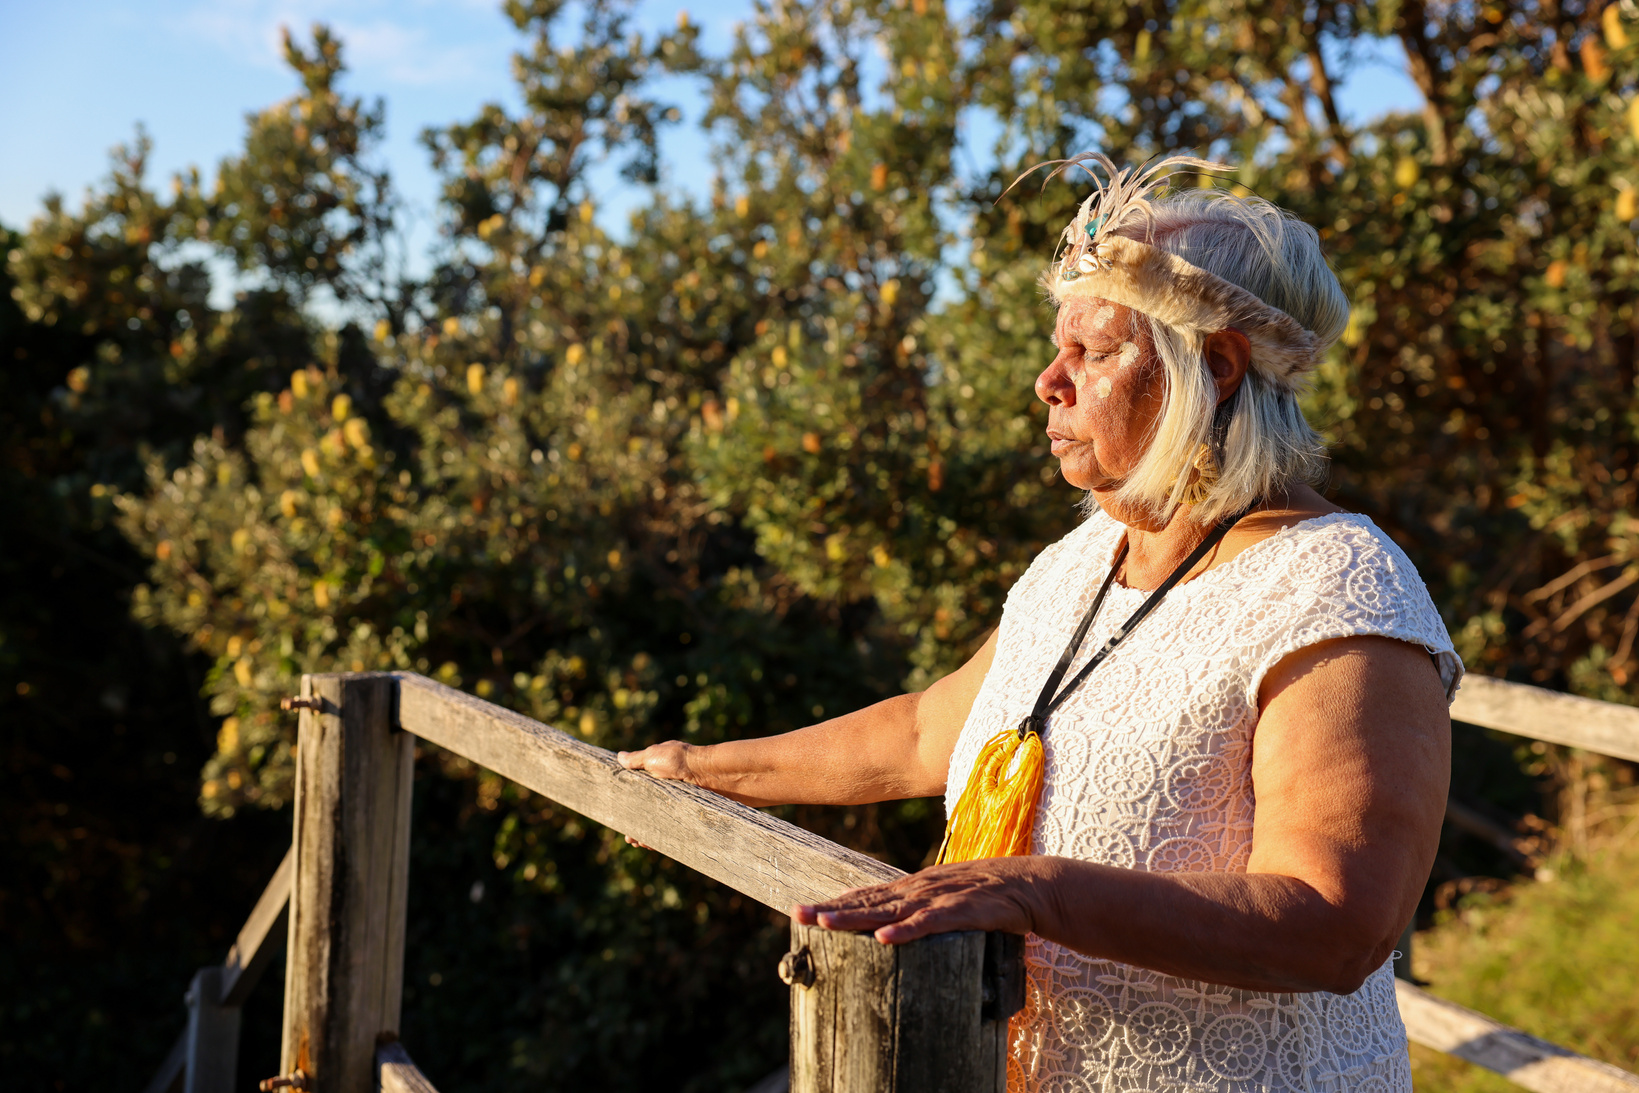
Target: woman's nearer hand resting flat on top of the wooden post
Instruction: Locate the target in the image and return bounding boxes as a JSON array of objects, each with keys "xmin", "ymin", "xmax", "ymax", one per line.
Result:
[{"xmin": 792, "ymin": 857, "xmax": 1041, "ymax": 946}]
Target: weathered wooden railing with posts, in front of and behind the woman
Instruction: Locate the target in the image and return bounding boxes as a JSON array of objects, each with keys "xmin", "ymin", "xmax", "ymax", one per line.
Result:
[{"xmin": 148, "ymin": 673, "xmax": 1639, "ymax": 1093}]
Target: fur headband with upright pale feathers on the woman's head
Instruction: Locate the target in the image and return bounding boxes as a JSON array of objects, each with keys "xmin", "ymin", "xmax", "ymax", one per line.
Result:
[{"xmin": 1008, "ymin": 152, "xmax": 1324, "ymax": 388}]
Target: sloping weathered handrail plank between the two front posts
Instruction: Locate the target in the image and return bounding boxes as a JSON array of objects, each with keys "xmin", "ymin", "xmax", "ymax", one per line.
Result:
[{"xmin": 397, "ymin": 673, "xmax": 905, "ymax": 911}]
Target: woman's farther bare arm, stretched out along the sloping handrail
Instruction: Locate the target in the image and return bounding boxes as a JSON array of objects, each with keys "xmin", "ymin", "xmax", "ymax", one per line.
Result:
[{"xmin": 620, "ymin": 634, "xmax": 997, "ymax": 806}]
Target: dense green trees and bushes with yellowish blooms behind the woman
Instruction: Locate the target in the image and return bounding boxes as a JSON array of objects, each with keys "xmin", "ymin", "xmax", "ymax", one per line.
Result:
[{"xmin": 9, "ymin": 0, "xmax": 1639, "ymax": 1090}]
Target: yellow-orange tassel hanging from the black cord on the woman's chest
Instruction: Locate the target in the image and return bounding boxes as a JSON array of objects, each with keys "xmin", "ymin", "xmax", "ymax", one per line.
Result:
[{"xmin": 939, "ymin": 729, "xmax": 1046, "ymax": 864}]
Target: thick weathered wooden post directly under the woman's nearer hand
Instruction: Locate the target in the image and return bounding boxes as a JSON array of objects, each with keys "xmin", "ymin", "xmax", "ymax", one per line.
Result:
[{"xmin": 780, "ymin": 923, "xmax": 1024, "ymax": 1093}]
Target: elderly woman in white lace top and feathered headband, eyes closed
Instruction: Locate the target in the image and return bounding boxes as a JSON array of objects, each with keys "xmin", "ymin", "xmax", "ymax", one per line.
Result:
[{"xmin": 621, "ymin": 157, "xmax": 1462, "ymax": 1093}]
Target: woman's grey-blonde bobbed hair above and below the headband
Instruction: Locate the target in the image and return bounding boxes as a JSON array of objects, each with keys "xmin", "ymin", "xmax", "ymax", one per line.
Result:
[{"xmin": 1085, "ymin": 190, "xmax": 1349, "ymax": 524}]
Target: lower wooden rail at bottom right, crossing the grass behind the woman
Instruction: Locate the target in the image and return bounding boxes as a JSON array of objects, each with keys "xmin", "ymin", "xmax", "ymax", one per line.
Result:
[{"xmin": 1395, "ymin": 980, "xmax": 1639, "ymax": 1093}]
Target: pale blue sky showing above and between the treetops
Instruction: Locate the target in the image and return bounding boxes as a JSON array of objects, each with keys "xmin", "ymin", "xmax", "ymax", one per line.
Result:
[{"xmin": 0, "ymin": 0, "xmax": 1418, "ymax": 249}]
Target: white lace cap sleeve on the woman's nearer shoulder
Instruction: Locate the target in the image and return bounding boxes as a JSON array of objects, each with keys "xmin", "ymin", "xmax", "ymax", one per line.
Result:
[{"xmin": 1246, "ymin": 515, "xmax": 1464, "ymax": 708}]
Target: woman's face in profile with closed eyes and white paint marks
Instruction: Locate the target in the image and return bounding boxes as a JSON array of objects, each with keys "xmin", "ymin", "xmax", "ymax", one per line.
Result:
[{"xmin": 1036, "ymin": 300, "xmax": 1162, "ymax": 493}]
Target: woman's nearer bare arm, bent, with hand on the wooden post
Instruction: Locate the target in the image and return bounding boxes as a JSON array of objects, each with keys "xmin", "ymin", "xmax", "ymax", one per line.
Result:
[{"xmin": 797, "ymin": 637, "xmax": 1451, "ymax": 993}]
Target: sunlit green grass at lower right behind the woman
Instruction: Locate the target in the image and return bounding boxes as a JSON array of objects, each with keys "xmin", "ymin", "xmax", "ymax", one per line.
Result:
[{"xmin": 1411, "ymin": 837, "xmax": 1639, "ymax": 1093}]
